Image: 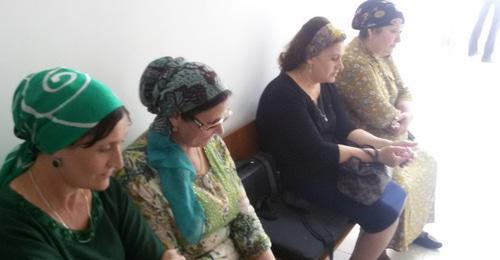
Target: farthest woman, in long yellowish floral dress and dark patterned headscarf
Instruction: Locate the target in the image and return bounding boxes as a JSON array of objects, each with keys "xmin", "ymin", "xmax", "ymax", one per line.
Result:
[{"xmin": 337, "ymin": 0, "xmax": 441, "ymax": 254}]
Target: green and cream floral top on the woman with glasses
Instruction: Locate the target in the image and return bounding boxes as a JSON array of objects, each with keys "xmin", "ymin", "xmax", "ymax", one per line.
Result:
[{"xmin": 116, "ymin": 134, "xmax": 271, "ymax": 259}]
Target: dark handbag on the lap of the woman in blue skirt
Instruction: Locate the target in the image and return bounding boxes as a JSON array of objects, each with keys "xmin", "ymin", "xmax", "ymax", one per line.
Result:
[{"xmin": 337, "ymin": 145, "xmax": 390, "ymax": 205}]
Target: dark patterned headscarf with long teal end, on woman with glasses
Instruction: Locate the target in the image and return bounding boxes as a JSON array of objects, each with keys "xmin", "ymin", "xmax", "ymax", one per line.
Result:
[{"xmin": 140, "ymin": 57, "xmax": 229, "ymax": 244}]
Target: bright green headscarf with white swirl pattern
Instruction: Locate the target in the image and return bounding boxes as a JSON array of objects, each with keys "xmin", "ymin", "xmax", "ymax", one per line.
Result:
[{"xmin": 0, "ymin": 68, "xmax": 122, "ymax": 187}]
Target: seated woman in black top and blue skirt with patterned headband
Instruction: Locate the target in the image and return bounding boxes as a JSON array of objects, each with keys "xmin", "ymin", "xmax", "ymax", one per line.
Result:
[{"xmin": 257, "ymin": 17, "xmax": 413, "ymax": 259}]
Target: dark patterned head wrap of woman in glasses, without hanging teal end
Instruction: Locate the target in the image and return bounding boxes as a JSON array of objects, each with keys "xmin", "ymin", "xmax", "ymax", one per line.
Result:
[{"xmin": 139, "ymin": 57, "xmax": 228, "ymax": 136}]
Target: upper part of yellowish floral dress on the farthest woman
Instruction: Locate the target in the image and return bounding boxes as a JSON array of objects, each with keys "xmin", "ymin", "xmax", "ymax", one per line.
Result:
[{"xmin": 335, "ymin": 38, "xmax": 411, "ymax": 139}]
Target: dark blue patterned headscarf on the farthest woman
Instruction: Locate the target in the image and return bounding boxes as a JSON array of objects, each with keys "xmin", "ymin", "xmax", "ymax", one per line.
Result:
[{"xmin": 352, "ymin": 0, "xmax": 405, "ymax": 30}]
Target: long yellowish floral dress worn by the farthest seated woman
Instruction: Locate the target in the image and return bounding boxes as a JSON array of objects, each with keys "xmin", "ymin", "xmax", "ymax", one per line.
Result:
[{"xmin": 336, "ymin": 38, "xmax": 437, "ymax": 251}]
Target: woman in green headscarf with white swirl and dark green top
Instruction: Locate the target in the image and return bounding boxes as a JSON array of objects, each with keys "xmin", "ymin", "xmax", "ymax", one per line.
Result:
[{"xmin": 0, "ymin": 68, "xmax": 171, "ymax": 259}]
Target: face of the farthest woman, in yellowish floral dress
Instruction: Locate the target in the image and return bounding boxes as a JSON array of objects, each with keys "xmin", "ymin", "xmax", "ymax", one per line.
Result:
[{"xmin": 368, "ymin": 23, "xmax": 403, "ymax": 57}]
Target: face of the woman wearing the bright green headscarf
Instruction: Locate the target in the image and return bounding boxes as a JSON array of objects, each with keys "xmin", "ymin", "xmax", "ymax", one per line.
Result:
[{"xmin": 53, "ymin": 116, "xmax": 129, "ymax": 190}]
